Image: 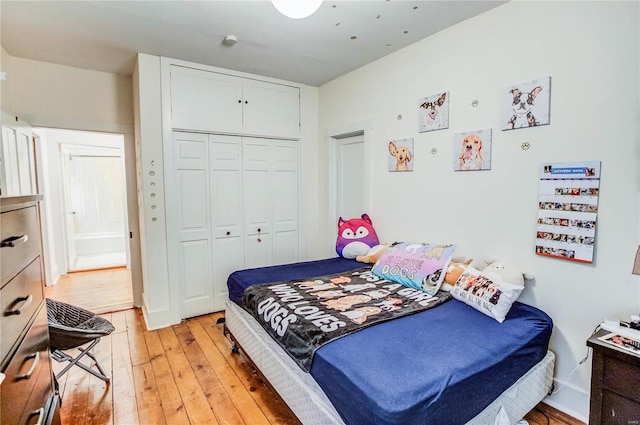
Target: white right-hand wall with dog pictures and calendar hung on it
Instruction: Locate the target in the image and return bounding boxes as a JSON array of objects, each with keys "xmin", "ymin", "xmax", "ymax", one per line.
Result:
[{"xmin": 319, "ymin": 1, "xmax": 640, "ymax": 420}]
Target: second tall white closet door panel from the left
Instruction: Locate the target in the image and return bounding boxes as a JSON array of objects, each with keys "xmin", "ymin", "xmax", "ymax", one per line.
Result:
[{"xmin": 209, "ymin": 135, "xmax": 244, "ymax": 311}]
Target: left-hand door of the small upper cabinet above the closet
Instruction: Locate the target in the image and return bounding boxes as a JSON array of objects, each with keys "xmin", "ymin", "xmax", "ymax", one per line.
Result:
[{"xmin": 171, "ymin": 66, "xmax": 243, "ymax": 133}]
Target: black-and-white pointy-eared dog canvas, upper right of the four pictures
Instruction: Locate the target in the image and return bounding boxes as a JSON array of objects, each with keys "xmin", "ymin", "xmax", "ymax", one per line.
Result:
[{"xmin": 502, "ymin": 77, "xmax": 551, "ymax": 130}]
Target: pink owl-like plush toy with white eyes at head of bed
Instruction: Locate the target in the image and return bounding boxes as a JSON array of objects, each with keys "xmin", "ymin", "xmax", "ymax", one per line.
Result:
[{"xmin": 336, "ymin": 214, "xmax": 380, "ymax": 259}]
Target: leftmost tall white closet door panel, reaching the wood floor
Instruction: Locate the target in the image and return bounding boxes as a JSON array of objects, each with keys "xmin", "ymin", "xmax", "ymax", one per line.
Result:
[{"xmin": 169, "ymin": 132, "xmax": 213, "ymax": 318}]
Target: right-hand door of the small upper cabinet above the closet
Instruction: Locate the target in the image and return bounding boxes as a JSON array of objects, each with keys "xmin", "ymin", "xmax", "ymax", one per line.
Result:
[{"xmin": 242, "ymin": 79, "xmax": 300, "ymax": 137}]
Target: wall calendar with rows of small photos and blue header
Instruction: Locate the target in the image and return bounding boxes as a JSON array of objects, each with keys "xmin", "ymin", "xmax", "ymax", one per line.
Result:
[{"xmin": 536, "ymin": 161, "xmax": 600, "ymax": 263}]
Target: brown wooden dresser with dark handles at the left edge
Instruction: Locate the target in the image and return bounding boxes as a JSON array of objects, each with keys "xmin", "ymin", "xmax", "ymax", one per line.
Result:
[{"xmin": 0, "ymin": 195, "xmax": 60, "ymax": 425}]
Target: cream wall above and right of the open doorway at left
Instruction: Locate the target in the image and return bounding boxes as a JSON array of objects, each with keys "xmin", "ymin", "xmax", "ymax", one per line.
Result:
[{"xmin": 0, "ymin": 48, "xmax": 142, "ymax": 305}]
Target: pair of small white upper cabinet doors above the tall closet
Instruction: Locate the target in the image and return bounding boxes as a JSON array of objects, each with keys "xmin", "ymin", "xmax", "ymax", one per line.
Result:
[{"xmin": 170, "ymin": 65, "xmax": 300, "ymax": 138}]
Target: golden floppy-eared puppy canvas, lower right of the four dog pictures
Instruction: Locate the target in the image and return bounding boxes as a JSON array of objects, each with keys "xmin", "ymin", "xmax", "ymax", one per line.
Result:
[{"xmin": 453, "ymin": 128, "xmax": 491, "ymax": 171}]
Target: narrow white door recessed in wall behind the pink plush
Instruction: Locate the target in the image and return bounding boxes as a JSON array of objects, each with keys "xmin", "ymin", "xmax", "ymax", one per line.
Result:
[{"xmin": 336, "ymin": 135, "xmax": 367, "ymax": 220}]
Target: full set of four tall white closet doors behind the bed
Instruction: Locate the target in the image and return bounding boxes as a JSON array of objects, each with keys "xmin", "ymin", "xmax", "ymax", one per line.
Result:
[{"xmin": 170, "ymin": 132, "xmax": 299, "ymax": 318}]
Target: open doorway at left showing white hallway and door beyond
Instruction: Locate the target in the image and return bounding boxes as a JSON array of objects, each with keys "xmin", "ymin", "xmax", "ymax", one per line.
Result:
[{"xmin": 33, "ymin": 128, "xmax": 133, "ymax": 309}]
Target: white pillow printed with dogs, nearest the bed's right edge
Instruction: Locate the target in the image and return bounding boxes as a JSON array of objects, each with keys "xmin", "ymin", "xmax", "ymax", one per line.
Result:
[{"xmin": 451, "ymin": 266, "xmax": 524, "ymax": 323}]
